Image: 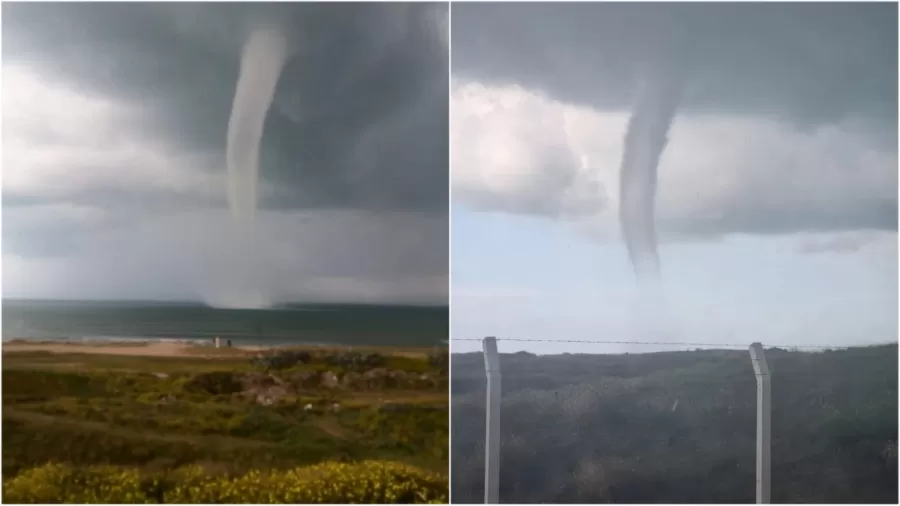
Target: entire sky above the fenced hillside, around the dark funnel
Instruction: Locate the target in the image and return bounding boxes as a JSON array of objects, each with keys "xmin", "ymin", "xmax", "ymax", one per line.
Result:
[{"xmin": 451, "ymin": 2, "xmax": 898, "ymax": 352}]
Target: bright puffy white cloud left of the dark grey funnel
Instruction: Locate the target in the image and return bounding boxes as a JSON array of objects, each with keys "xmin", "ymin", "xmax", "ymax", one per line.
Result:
[{"xmin": 450, "ymin": 83, "xmax": 602, "ymax": 214}]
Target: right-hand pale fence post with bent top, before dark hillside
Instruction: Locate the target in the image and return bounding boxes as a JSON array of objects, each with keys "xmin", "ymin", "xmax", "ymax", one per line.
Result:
[{"xmin": 750, "ymin": 343, "xmax": 772, "ymax": 504}]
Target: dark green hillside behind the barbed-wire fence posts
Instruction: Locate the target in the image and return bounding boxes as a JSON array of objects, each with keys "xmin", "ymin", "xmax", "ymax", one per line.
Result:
[{"xmin": 452, "ymin": 345, "xmax": 897, "ymax": 504}]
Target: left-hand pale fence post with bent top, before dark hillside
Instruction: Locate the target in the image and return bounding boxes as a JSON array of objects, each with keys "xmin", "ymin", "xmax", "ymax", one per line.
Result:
[{"xmin": 481, "ymin": 337, "xmax": 500, "ymax": 504}]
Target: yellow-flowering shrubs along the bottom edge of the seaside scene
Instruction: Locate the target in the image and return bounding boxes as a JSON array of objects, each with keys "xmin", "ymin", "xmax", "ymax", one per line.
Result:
[{"xmin": 3, "ymin": 461, "xmax": 448, "ymax": 504}]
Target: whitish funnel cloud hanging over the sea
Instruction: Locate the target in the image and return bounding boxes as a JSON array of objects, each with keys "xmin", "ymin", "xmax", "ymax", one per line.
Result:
[{"xmin": 225, "ymin": 26, "xmax": 288, "ymax": 223}]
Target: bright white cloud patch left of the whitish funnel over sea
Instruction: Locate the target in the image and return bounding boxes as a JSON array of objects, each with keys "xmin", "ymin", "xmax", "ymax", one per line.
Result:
[{"xmin": 3, "ymin": 63, "xmax": 224, "ymax": 202}]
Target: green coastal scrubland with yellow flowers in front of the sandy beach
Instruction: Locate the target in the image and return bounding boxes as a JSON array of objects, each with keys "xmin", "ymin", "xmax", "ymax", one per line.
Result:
[{"xmin": 3, "ymin": 350, "xmax": 448, "ymax": 502}]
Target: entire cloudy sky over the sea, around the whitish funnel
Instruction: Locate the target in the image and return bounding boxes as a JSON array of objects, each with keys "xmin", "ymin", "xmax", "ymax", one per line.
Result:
[{"xmin": 2, "ymin": 3, "xmax": 449, "ymax": 306}]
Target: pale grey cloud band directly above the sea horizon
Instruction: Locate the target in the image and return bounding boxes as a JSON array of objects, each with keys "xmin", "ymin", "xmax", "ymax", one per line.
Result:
[{"xmin": 4, "ymin": 209, "xmax": 448, "ymax": 304}]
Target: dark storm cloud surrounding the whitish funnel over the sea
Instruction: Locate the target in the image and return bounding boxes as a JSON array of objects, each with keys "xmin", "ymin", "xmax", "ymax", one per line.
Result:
[{"xmin": 3, "ymin": 3, "xmax": 448, "ymax": 211}]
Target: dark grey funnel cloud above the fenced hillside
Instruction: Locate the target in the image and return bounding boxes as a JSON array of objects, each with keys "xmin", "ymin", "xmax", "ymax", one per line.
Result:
[{"xmin": 619, "ymin": 72, "xmax": 681, "ymax": 281}]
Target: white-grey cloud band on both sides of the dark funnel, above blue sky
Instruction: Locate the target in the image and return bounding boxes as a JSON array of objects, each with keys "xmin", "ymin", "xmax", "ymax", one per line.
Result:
[{"xmin": 451, "ymin": 82, "xmax": 898, "ymax": 239}]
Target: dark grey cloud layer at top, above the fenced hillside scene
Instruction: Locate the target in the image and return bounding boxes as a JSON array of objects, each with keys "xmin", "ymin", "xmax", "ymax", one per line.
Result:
[{"xmin": 452, "ymin": 2, "xmax": 897, "ymax": 131}]
